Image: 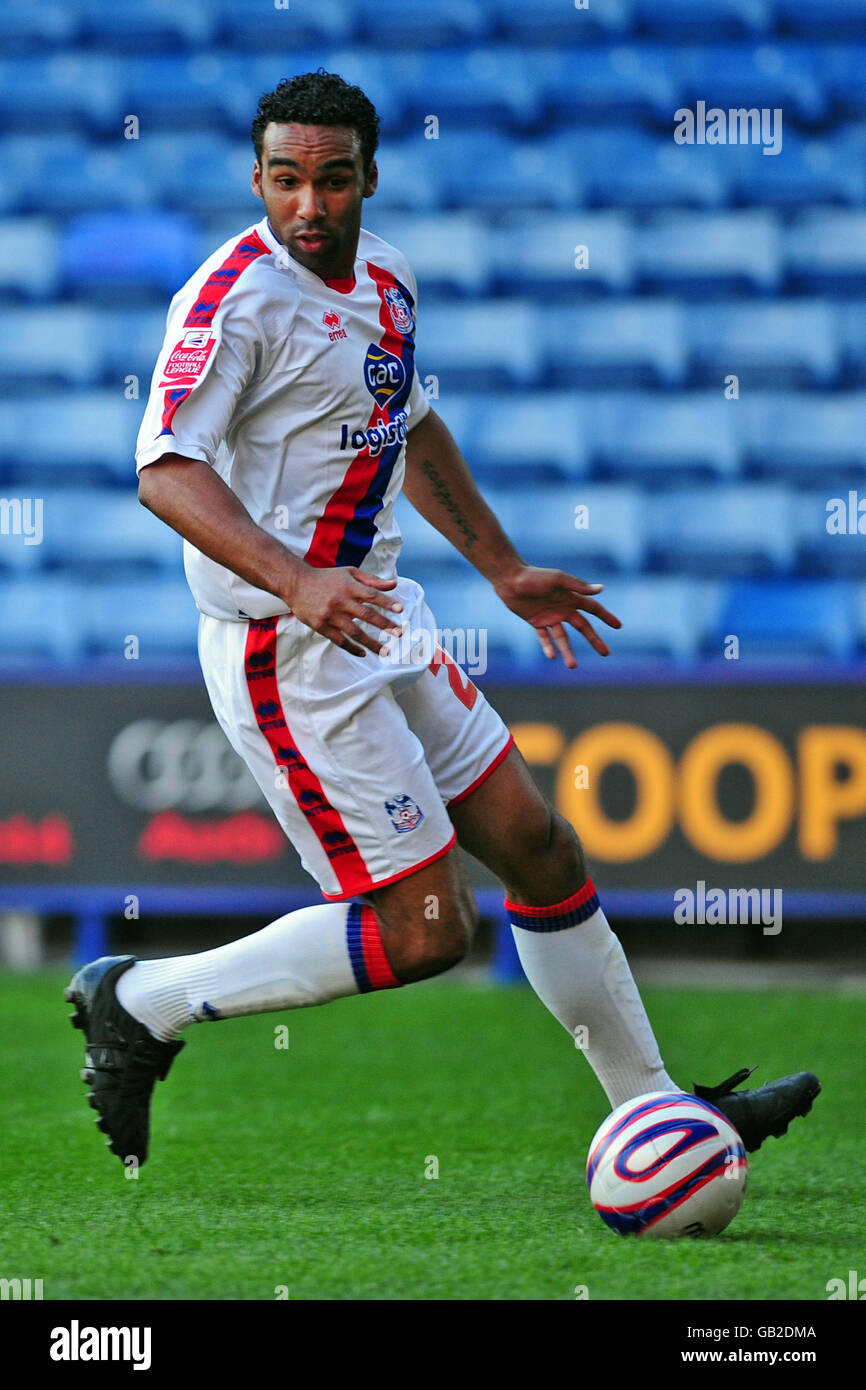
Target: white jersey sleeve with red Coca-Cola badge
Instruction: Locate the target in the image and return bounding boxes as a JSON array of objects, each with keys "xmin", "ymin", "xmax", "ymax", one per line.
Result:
[{"xmin": 135, "ymin": 273, "xmax": 261, "ymax": 473}]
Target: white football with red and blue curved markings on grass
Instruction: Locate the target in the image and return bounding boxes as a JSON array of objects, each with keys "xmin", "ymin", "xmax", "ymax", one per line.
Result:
[{"xmin": 587, "ymin": 1091, "xmax": 749, "ymax": 1240}]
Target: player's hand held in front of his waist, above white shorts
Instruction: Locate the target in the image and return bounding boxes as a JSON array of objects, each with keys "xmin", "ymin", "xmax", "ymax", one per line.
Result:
[{"xmin": 291, "ymin": 564, "xmax": 403, "ymax": 656}]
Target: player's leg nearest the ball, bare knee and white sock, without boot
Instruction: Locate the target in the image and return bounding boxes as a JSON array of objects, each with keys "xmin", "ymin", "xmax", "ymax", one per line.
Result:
[{"xmin": 449, "ymin": 748, "xmax": 681, "ymax": 1108}]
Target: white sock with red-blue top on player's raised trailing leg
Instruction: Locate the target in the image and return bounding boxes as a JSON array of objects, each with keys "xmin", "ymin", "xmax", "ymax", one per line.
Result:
[{"xmin": 117, "ymin": 902, "xmax": 400, "ymax": 1043}]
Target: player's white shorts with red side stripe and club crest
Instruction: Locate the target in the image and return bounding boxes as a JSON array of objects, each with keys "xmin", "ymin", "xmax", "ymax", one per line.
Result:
[{"xmin": 199, "ymin": 578, "xmax": 513, "ymax": 901}]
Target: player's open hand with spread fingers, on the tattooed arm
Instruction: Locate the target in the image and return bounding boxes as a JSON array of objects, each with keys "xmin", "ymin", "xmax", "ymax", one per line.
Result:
[{"xmin": 495, "ymin": 564, "xmax": 623, "ymax": 670}]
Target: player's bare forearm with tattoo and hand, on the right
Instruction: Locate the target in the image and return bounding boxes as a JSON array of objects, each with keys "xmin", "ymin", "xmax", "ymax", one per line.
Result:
[{"xmin": 403, "ymin": 410, "xmax": 623, "ymax": 669}]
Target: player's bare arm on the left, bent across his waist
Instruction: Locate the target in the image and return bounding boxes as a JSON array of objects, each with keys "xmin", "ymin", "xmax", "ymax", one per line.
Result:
[{"xmin": 139, "ymin": 453, "xmax": 402, "ymax": 656}]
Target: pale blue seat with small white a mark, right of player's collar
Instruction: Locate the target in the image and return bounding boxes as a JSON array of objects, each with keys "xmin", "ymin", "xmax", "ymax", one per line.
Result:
[{"xmin": 500, "ymin": 211, "xmax": 635, "ymax": 293}]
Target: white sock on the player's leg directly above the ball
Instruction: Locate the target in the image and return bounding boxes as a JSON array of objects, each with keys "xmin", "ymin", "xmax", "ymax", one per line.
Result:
[{"xmin": 506, "ymin": 878, "xmax": 681, "ymax": 1109}]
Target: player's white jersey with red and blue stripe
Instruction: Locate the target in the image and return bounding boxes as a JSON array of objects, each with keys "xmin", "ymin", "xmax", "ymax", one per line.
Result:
[{"xmin": 136, "ymin": 218, "xmax": 430, "ymax": 620}]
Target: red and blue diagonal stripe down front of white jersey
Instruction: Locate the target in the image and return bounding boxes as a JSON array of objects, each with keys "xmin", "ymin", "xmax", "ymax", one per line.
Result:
[{"xmin": 304, "ymin": 261, "xmax": 414, "ymax": 569}]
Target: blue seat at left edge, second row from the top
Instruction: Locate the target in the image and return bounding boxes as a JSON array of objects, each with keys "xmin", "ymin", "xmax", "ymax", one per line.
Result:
[{"xmin": 0, "ymin": 51, "xmax": 125, "ymax": 135}]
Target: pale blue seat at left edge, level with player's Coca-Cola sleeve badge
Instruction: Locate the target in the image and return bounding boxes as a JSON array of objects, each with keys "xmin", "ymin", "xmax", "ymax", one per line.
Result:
[{"xmin": 0, "ymin": 304, "xmax": 101, "ymax": 389}]
